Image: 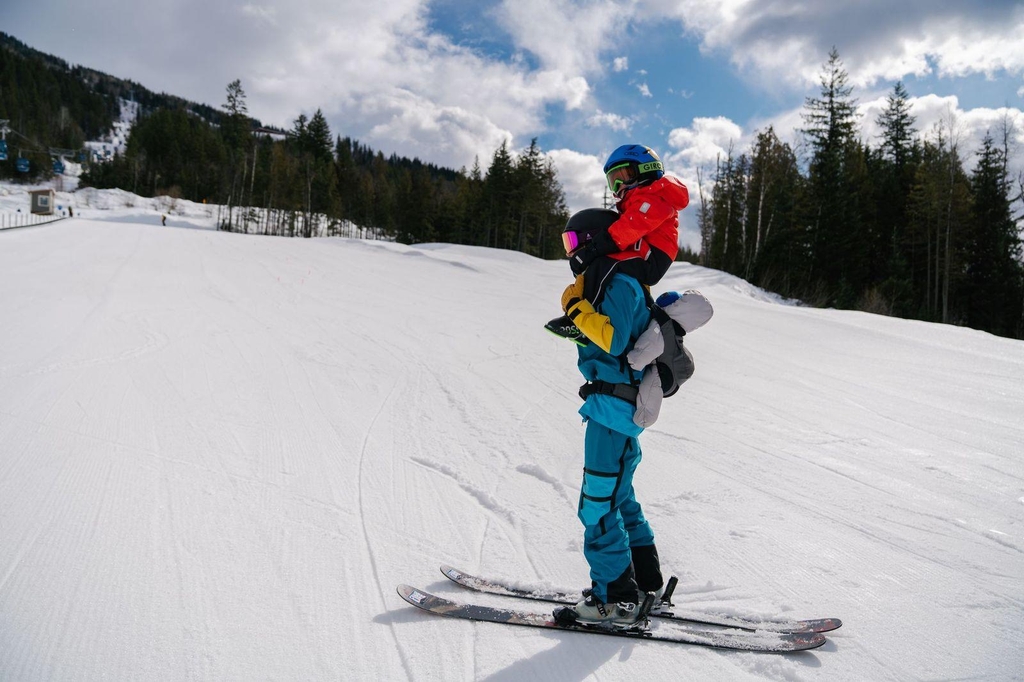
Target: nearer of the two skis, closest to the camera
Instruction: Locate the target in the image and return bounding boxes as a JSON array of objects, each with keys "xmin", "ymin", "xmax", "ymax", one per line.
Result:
[{"xmin": 398, "ymin": 585, "xmax": 825, "ymax": 652}]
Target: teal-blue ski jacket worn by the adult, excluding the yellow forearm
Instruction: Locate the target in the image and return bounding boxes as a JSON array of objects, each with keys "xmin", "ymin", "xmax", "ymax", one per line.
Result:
[{"xmin": 577, "ymin": 273, "xmax": 650, "ymax": 436}]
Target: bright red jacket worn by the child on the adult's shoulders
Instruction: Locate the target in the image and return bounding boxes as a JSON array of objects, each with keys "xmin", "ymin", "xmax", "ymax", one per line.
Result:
[{"xmin": 608, "ymin": 175, "xmax": 690, "ymax": 260}]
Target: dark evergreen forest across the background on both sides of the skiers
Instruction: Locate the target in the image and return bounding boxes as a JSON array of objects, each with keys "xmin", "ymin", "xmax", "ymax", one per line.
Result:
[{"xmin": 0, "ymin": 34, "xmax": 1024, "ymax": 338}]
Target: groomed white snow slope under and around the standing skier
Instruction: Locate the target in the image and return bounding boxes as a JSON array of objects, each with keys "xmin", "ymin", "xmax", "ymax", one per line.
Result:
[{"xmin": 0, "ymin": 212, "xmax": 1024, "ymax": 682}]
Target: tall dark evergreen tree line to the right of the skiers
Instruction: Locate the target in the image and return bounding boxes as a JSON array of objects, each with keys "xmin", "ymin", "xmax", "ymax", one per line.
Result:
[{"xmin": 695, "ymin": 49, "xmax": 1024, "ymax": 338}]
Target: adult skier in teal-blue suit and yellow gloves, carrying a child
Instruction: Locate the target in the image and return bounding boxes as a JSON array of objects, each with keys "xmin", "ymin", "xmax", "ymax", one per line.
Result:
[{"xmin": 561, "ymin": 209, "xmax": 664, "ymax": 627}]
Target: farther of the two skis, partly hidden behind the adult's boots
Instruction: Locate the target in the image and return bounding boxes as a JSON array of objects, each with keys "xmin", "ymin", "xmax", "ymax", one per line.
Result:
[{"xmin": 441, "ymin": 565, "xmax": 843, "ymax": 633}]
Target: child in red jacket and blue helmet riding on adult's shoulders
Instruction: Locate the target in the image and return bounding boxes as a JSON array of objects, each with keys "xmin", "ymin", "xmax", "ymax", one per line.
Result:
[{"xmin": 545, "ymin": 144, "xmax": 690, "ymax": 344}]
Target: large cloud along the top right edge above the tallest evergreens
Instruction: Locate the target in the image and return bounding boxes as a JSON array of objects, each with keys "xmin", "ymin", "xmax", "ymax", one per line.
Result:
[{"xmin": 638, "ymin": 0, "xmax": 1024, "ymax": 89}]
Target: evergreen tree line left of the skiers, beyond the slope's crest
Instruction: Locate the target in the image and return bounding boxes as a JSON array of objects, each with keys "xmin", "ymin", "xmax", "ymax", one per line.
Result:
[{"xmin": 82, "ymin": 81, "xmax": 567, "ymax": 258}]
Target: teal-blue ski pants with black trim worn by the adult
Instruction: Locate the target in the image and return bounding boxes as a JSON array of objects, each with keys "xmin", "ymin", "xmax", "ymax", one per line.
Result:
[{"xmin": 579, "ymin": 420, "xmax": 654, "ymax": 602}]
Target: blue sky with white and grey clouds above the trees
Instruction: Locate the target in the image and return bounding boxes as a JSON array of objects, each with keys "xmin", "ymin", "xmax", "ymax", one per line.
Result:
[{"xmin": 0, "ymin": 0, "xmax": 1024, "ymax": 246}]
